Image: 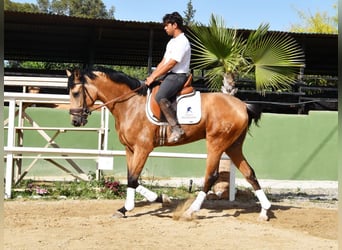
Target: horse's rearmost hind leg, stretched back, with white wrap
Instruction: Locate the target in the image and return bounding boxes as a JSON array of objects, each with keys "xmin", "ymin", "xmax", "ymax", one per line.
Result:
[{"xmin": 226, "ymin": 141, "xmax": 271, "ymax": 220}]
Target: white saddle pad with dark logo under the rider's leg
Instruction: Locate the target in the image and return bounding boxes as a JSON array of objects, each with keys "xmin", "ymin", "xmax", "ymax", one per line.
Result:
[{"xmin": 146, "ymin": 90, "xmax": 201, "ymax": 125}]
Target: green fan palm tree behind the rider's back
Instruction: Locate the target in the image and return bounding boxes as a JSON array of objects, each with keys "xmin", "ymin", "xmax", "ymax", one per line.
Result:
[{"xmin": 190, "ymin": 15, "xmax": 304, "ymax": 94}]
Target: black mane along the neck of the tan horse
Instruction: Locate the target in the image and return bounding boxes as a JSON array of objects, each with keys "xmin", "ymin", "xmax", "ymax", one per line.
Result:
[{"xmin": 73, "ymin": 67, "xmax": 146, "ymax": 95}]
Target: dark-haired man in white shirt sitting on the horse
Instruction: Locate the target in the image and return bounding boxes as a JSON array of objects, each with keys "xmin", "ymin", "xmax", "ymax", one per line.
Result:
[{"xmin": 145, "ymin": 12, "xmax": 191, "ymax": 143}]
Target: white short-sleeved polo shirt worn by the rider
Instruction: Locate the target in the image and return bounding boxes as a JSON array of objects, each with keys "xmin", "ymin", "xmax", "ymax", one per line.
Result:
[{"xmin": 164, "ymin": 33, "xmax": 191, "ymax": 73}]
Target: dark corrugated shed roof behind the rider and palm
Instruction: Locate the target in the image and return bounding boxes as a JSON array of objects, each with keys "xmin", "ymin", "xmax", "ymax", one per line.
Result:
[{"xmin": 4, "ymin": 11, "xmax": 338, "ymax": 76}]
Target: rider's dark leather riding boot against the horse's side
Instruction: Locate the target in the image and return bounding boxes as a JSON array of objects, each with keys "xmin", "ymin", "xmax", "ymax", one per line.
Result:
[{"xmin": 159, "ymin": 98, "xmax": 184, "ymax": 143}]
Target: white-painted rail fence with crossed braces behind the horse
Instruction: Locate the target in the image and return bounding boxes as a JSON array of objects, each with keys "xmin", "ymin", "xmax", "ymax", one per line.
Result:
[{"xmin": 4, "ymin": 76, "xmax": 235, "ymax": 200}]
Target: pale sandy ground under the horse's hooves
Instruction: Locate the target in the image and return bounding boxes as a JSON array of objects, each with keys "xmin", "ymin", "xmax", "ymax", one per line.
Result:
[{"xmin": 4, "ymin": 195, "xmax": 338, "ymax": 250}]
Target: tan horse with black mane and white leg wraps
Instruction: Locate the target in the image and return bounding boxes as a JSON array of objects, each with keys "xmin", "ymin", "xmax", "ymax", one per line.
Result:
[{"xmin": 66, "ymin": 68, "xmax": 271, "ymax": 220}]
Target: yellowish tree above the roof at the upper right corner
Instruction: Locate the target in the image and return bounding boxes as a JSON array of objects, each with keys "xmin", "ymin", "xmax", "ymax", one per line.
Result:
[{"xmin": 290, "ymin": 2, "xmax": 338, "ymax": 34}]
